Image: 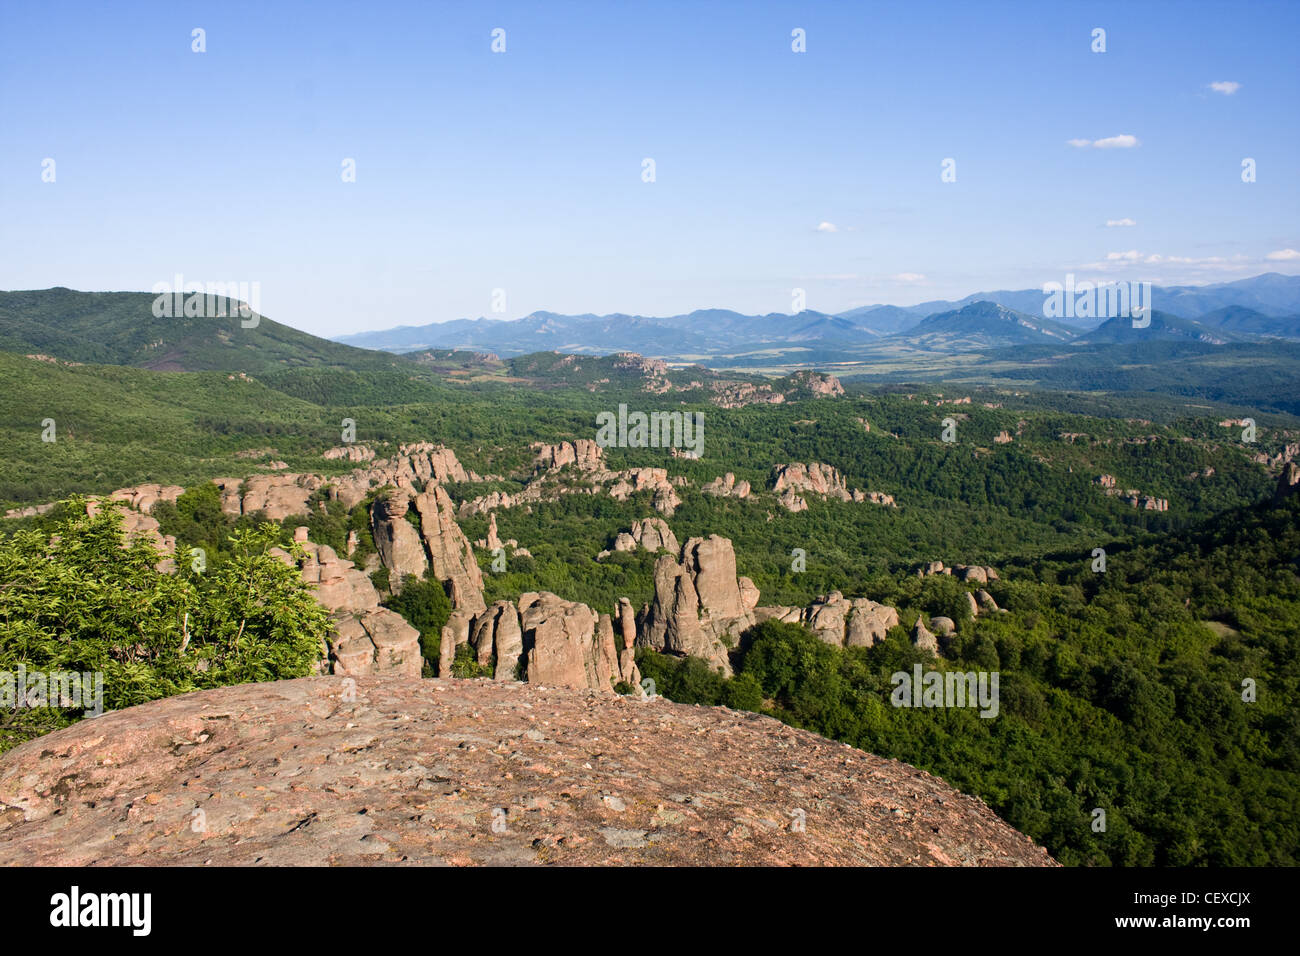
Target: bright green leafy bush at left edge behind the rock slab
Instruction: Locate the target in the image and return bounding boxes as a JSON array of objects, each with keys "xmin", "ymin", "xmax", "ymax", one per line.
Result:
[{"xmin": 0, "ymin": 498, "xmax": 329, "ymax": 747}]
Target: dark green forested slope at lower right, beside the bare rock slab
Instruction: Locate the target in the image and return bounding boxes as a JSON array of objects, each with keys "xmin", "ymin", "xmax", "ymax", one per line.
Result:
[{"xmin": 637, "ymin": 494, "xmax": 1300, "ymax": 866}]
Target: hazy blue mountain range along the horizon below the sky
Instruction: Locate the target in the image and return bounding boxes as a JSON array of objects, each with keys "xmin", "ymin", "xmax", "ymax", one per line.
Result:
[{"xmin": 335, "ymin": 273, "xmax": 1300, "ymax": 360}]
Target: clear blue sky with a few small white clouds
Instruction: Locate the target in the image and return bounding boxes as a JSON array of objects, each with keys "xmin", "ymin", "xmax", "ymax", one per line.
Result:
[{"xmin": 0, "ymin": 0, "xmax": 1300, "ymax": 334}]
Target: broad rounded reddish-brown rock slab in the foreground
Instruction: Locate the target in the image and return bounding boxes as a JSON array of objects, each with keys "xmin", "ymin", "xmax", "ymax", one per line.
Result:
[{"xmin": 0, "ymin": 676, "xmax": 1054, "ymax": 866}]
